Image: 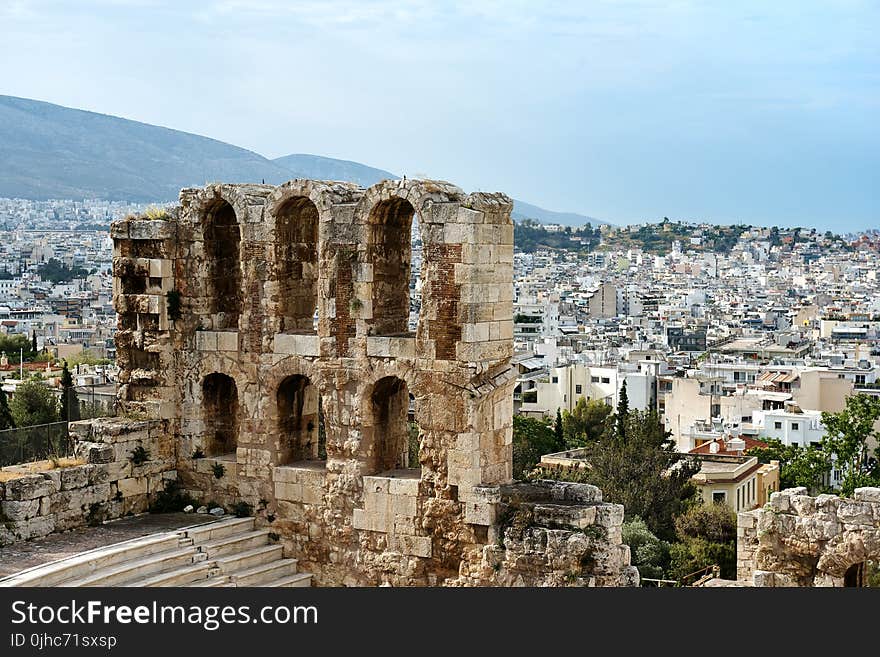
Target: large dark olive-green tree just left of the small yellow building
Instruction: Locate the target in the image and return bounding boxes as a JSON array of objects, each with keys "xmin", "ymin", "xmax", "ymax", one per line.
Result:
[{"xmin": 585, "ymin": 410, "xmax": 700, "ymax": 540}]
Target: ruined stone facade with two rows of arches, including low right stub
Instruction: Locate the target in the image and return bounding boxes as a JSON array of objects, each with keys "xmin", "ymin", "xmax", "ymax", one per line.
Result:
[{"xmin": 111, "ymin": 180, "xmax": 638, "ymax": 585}]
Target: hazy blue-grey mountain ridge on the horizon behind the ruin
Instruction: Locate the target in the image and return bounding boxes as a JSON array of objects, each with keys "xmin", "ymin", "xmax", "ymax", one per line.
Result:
[{"xmin": 0, "ymin": 95, "xmax": 607, "ymax": 226}]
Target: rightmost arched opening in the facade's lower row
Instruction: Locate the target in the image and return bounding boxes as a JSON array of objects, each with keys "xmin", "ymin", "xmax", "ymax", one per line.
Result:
[{"xmin": 370, "ymin": 376, "xmax": 419, "ymax": 472}]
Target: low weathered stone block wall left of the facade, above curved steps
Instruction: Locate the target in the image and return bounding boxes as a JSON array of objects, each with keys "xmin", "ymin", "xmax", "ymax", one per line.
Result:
[{"xmin": 0, "ymin": 418, "xmax": 177, "ymax": 545}]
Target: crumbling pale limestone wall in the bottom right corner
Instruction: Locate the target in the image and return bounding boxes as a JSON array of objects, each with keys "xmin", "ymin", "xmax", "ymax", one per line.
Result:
[{"xmin": 737, "ymin": 488, "xmax": 880, "ymax": 586}]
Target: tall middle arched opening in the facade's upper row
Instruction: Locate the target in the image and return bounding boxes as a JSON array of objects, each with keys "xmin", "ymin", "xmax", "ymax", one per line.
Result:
[{"xmin": 275, "ymin": 196, "xmax": 318, "ymax": 333}]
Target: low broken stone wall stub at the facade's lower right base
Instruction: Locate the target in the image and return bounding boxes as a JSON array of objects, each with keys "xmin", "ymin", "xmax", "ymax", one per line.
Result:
[{"xmin": 452, "ymin": 481, "xmax": 639, "ymax": 586}]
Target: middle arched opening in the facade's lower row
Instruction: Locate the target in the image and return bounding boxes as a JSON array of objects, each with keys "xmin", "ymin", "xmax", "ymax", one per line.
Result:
[{"xmin": 276, "ymin": 375, "xmax": 327, "ymax": 464}]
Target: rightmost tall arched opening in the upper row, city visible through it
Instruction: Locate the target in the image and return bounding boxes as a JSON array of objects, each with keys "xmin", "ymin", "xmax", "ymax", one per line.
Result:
[{"xmin": 367, "ymin": 197, "xmax": 418, "ymax": 335}]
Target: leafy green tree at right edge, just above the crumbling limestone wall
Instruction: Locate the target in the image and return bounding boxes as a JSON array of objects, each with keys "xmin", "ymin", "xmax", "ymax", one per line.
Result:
[{"xmin": 822, "ymin": 394, "xmax": 880, "ymax": 496}]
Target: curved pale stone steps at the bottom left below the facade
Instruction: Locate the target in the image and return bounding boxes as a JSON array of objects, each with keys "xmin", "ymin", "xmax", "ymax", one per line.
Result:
[{"xmin": 0, "ymin": 518, "xmax": 312, "ymax": 587}]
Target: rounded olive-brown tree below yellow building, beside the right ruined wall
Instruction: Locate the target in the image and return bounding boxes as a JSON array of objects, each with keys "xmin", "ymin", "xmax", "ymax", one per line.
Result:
[{"xmin": 669, "ymin": 503, "xmax": 736, "ymax": 580}]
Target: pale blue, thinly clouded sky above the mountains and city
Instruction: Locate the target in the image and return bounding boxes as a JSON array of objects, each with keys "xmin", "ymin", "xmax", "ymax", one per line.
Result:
[{"xmin": 0, "ymin": 0, "xmax": 880, "ymax": 232}]
